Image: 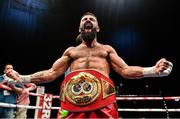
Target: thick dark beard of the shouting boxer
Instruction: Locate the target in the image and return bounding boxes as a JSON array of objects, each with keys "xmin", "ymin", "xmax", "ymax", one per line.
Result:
[{"xmin": 81, "ymin": 28, "xmax": 97, "ymax": 44}]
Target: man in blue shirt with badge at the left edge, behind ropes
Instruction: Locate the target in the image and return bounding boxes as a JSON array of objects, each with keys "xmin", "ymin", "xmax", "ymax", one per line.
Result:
[{"xmin": 0, "ymin": 63, "xmax": 22, "ymax": 119}]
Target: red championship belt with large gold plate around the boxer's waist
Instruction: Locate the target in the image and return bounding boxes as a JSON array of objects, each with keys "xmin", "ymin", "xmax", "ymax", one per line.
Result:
[{"xmin": 60, "ymin": 70, "xmax": 116, "ymax": 112}]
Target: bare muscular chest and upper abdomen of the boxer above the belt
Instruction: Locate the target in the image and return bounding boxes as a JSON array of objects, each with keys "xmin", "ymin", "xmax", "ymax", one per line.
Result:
[{"xmin": 70, "ymin": 45, "xmax": 108, "ymax": 70}]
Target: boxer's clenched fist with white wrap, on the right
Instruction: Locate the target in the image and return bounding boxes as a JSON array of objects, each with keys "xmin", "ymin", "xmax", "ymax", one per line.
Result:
[{"xmin": 154, "ymin": 58, "xmax": 173, "ymax": 76}]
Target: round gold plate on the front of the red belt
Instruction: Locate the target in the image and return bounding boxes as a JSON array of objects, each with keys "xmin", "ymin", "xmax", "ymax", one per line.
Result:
[{"xmin": 64, "ymin": 72, "xmax": 101, "ymax": 106}]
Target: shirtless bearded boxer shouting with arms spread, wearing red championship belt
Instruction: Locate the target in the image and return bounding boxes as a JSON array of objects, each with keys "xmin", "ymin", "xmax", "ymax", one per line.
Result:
[{"xmin": 6, "ymin": 12, "xmax": 172, "ymax": 118}]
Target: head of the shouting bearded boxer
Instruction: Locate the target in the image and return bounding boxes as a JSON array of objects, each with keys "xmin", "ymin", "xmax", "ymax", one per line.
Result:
[{"xmin": 79, "ymin": 15, "xmax": 99, "ymax": 44}]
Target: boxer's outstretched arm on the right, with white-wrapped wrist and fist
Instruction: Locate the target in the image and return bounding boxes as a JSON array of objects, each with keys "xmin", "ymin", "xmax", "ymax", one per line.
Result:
[{"xmin": 108, "ymin": 46, "xmax": 173, "ymax": 79}]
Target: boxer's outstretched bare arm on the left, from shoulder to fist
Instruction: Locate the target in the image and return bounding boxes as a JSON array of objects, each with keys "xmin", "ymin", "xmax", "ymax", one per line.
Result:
[{"xmin": 8, "ymin": 47, "xmax": 73, "ymax": 83}]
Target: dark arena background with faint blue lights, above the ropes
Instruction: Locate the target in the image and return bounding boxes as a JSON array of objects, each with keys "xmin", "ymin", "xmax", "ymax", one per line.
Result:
[{"xmin": 0, "ymin": 0, "xmax": 180, "ymax": 118}]
